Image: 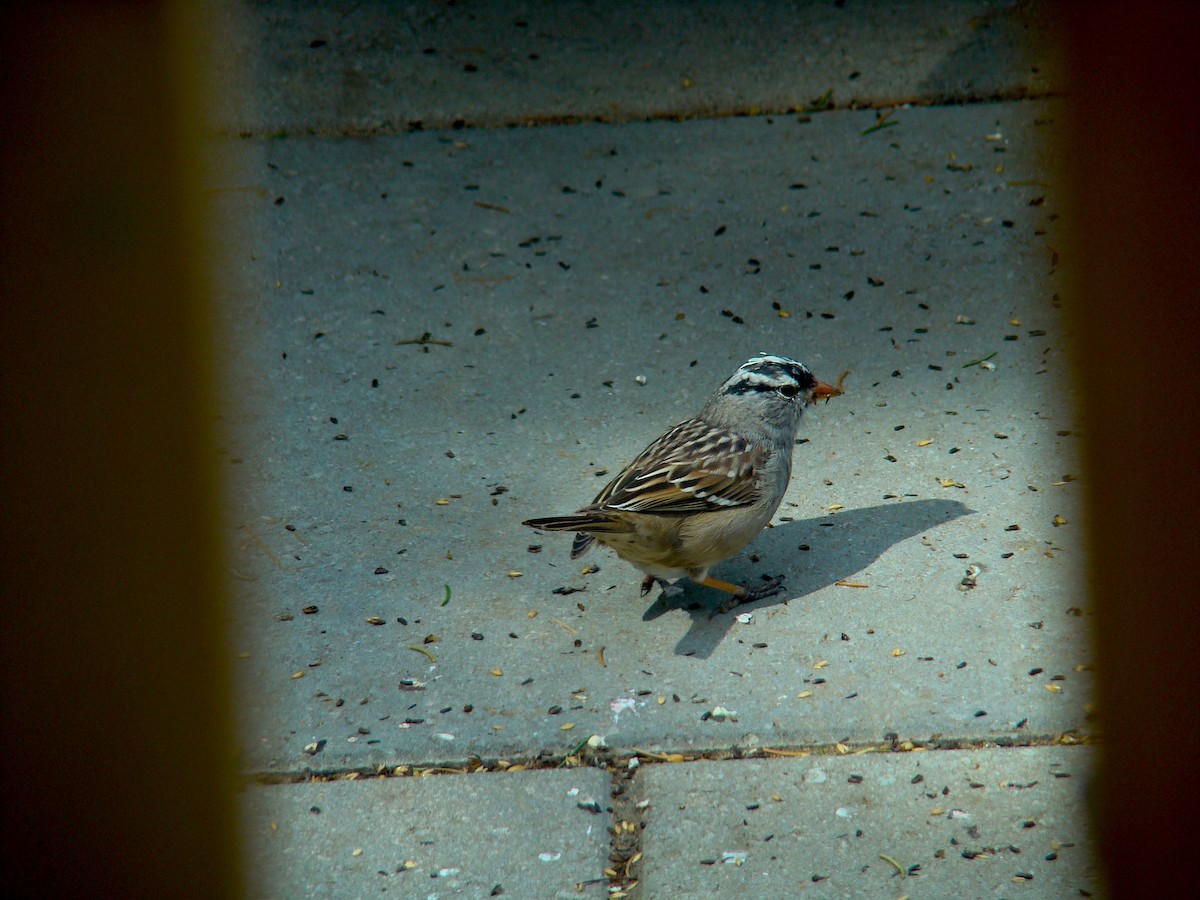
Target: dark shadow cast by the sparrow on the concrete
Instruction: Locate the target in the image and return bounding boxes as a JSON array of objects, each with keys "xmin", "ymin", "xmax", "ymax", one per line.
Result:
[{"xmin": 642, "ymin": 499, "xmax": 974, "ymax": 659}]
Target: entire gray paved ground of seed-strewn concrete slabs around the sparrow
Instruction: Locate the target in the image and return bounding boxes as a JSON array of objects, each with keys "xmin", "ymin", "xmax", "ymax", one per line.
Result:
[{"xmin": 214, "ymin": 4, "xmax": 1096, "ymax": 896}]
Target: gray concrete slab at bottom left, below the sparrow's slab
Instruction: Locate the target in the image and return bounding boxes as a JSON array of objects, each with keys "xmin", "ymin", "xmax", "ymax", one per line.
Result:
[{"xmin": 241, "ymin": 769, "xmax": 610, "ymax": 900}]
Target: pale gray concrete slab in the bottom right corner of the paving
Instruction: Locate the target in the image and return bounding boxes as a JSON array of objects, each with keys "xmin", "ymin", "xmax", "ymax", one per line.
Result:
[{"xmin": 637, "ymin": 748, "xmax": 1099, "ymax": 900}]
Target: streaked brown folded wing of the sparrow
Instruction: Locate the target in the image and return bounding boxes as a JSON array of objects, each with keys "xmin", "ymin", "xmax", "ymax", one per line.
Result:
[{"xmin": 584, "ymin": 419, "xmax": 766, "ymax": 515}]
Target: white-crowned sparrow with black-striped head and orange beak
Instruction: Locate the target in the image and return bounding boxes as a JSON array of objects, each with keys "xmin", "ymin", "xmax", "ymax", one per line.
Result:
[{"xmin": 523, "ymin": 355, "xmax": 841, "ymax": 611}]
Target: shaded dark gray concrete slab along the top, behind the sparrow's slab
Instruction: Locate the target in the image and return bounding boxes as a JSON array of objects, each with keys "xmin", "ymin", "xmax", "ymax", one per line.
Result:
[{"xmin": 216, "ymin": 0, "xmax": 1061, "ymax": 136}]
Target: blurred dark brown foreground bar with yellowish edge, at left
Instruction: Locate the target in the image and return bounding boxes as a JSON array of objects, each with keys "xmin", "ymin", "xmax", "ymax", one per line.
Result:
[{"xmin": 0, "ymin": 1, "xmax": 240, "ymax": 898}]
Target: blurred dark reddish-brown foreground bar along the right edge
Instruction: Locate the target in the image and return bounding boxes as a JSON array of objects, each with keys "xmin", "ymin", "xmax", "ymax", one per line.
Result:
[{"xmin": 1058, "ymin": 2, "xmax": 1200, "ymax": 898}]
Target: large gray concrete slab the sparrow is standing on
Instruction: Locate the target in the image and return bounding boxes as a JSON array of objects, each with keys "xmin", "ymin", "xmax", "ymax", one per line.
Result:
[{"xmin": 213, "ymin": 101, "xmax": 1091, "ymax": 773}]
